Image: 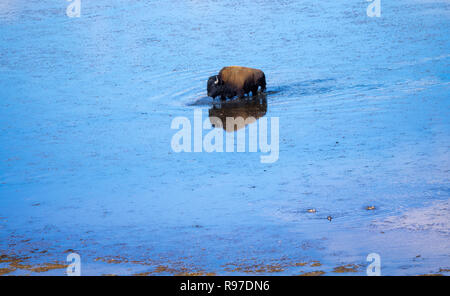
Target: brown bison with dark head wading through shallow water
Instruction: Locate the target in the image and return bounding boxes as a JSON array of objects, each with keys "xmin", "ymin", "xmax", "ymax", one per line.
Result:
[{"xmin": 207, "ymin": 66, "xmax": 266, "ymax": 100}]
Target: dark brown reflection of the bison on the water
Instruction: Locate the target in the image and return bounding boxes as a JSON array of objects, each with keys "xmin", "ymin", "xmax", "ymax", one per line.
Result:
[{"xmin": 209, "ymin": 93, "xmax": 267, "ymax": 132}]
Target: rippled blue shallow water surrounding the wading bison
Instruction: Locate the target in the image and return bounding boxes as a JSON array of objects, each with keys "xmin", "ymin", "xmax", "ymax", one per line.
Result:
[{"xmin": 0, "ymin": 0, "xmax": 450, "ymax": 275}]
